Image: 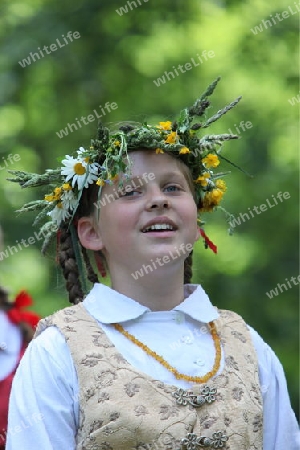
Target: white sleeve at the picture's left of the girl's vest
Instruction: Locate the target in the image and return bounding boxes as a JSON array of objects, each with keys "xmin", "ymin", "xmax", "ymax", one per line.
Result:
[{"xmin": 6, "ymin": 327, "xmax": 78, "ymax": 450}]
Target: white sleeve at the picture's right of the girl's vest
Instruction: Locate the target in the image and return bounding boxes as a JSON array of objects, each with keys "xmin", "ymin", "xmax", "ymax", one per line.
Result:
[{"xmin": 249, "ymin": 327, "xmax": 300, "ymax": 450}]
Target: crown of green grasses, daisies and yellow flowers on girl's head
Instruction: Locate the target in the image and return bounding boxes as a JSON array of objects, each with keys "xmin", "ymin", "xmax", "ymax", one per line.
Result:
[{"xmin": 8, "ymin": 77, "xmax": 241, "ymax": 253}]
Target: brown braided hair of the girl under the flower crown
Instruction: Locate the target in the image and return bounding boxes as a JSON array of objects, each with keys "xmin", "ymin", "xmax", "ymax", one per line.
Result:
[{"xmin": 59, "ymin": 149, "xmax": 196, "ymax": 304}]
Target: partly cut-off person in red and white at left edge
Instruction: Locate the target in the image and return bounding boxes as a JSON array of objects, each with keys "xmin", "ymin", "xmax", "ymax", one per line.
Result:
[{"xmin": 0, "ymin": 229, "xmax": 40, "ymax": 450}]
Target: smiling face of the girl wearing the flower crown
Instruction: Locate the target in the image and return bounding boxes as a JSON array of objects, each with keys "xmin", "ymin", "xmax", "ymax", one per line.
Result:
[{"xmin": 78, "ymin": 150, "xmax": 199, "ymax": 272}]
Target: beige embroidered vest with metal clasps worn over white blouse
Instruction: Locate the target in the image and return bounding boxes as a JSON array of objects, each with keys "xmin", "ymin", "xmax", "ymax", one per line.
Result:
[{"xmin": 37, "ymin": 304, "xmax": 263, "ymax": 450}]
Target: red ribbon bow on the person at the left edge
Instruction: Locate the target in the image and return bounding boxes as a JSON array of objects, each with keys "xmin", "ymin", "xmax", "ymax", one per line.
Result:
[{"xmin": 6, "ymin": 291, "xmax": 40, "ymax": 329}]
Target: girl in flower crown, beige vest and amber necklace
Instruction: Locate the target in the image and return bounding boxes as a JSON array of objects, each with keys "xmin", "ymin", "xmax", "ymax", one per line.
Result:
[{"xmin": 7, "ymin": 80, "xmax": 299, "ymax": 450}]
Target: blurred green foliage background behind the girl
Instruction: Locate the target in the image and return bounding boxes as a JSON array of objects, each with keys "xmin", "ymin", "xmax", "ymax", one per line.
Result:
[{"xmin": 0, "ymin": 0, "xmax": 299, "ymax": 413}]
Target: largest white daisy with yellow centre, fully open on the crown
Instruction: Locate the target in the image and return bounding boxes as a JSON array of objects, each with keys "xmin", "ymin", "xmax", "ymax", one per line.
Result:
[{"xmin": 60, "ymin": 155, "xmax": 99, "ymax": 191}]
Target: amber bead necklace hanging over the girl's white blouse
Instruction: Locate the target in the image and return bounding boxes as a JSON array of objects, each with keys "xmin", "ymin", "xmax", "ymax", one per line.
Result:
[{"xmin": 113, "ymin": 322, "xmax": 221, "ymax": 383}]
